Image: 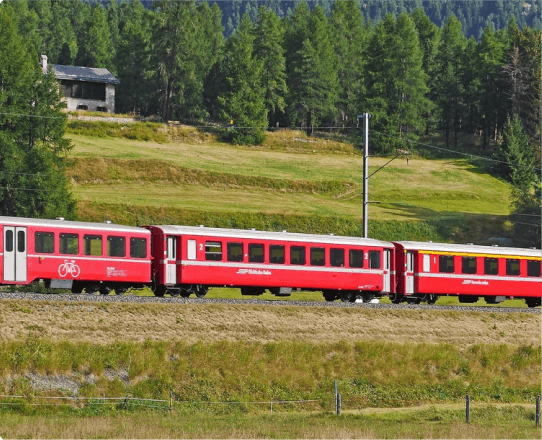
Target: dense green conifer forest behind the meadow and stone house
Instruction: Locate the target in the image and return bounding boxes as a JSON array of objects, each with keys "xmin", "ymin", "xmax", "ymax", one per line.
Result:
[{"xmin": 0, "ymin": 0, "xmax": 542, "ymax": 244}]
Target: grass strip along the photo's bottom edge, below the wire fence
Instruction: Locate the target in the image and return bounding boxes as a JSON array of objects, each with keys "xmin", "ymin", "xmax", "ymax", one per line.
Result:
[{"xmin": 0, "ymin": 406, "xmax": 539, "ymax": 440}]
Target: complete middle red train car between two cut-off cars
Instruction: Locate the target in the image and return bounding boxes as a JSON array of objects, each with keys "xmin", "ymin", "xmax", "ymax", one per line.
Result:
[{"xmin": 147, "ymin": 225, "xmax": 395, "ymax": 301}]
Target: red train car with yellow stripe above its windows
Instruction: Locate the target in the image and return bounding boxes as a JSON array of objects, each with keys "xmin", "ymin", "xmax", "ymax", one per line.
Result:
[{"xmin": 396, "ymin": 241, "xmax": 542, "ymax": 307}]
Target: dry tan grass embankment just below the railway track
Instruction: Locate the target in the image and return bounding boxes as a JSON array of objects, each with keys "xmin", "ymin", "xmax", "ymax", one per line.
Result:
[{"xmin": 0, "ymin": 295, "xmax": 541, "ymax": 347}]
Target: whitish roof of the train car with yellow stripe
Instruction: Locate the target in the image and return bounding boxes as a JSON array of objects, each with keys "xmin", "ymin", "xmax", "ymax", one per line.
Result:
[{"xmin": 394, "ymin": 241, "xmax": 542, "ymax": 257}]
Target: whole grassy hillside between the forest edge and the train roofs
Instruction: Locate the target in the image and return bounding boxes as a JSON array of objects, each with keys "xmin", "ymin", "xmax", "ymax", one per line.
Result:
[{"xmin": 69, "ymin": 122, "xmax": 510, "ymax": 242}]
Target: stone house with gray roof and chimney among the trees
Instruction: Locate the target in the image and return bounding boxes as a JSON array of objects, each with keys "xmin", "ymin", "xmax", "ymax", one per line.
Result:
[{"xmin": 41, "ymin": 55, "xmax": 120, "ymax": 113}]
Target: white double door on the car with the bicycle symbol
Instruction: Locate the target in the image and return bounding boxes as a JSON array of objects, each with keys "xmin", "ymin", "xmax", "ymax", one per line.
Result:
[{"xmin": 4, "ymin": 226, "xmax": 27, "ymax": 281}]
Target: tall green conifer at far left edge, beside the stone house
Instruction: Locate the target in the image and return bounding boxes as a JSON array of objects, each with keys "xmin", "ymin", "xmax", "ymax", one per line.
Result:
[{"xmin": 0, "ymin": 4, "xmax": 75, "ymax": 218}]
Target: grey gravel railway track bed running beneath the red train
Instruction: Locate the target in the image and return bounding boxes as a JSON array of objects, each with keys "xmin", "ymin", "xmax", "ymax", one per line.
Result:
[{"xmin": 0, "ymin": 292, "xmax": 541, "ymax": 314}]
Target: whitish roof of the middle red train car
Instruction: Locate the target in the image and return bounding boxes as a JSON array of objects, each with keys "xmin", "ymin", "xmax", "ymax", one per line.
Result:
[{"xmin": 152, "ymin": 225, "xmax": 393, "ymax": 248}]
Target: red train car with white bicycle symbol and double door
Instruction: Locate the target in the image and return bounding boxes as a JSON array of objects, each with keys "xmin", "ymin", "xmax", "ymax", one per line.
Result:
[{"xmin": 0, "ymin": 217, "xmax": 151, "ymax": 294}]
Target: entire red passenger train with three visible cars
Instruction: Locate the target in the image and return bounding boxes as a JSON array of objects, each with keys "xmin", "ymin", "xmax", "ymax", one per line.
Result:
[{"xmin": 0, "ymin": 217, "xmax": 542, "ymax": 307}]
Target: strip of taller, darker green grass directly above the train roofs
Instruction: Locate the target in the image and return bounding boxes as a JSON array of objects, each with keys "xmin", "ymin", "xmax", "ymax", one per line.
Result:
[{"xmin": 78, "ymin": 201, "xmax": 507, "ymax": 242}]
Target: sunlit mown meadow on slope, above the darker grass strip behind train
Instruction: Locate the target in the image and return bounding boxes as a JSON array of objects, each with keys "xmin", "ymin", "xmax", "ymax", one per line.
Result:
[{"xmin": 69, "ymin": 125, "xmax": 511, "ymax": 239}]
